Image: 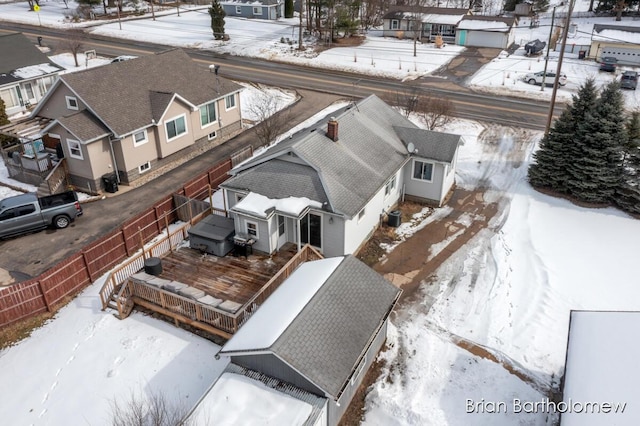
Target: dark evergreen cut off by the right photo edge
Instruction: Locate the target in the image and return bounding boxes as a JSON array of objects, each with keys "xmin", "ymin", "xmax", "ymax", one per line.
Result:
[{"xmin": 615, "ymin": 111, "xmax": 640, "ymax": 214}]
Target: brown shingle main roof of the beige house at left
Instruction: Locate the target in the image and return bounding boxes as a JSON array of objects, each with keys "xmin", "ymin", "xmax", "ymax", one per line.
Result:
[{"xmin": 55, "ymin": 49, "xmax": 241, "ymax": 136}]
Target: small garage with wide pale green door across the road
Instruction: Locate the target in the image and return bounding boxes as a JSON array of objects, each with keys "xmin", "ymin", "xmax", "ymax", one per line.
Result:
[{"xmin": 456, "ymin": 15, "xmax": 516, "ymax": 49}]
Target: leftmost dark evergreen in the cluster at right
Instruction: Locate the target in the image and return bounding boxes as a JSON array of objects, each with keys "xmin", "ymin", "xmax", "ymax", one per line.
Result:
[{"xmin": 529, "ymin": 79, "xmax": 597, "ymax": 193}]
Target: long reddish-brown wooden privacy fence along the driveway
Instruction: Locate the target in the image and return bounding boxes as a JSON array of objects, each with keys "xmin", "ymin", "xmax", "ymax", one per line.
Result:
[{"xmin": 0, "ymin": 159, "xmax": 231, "ymax": 329}]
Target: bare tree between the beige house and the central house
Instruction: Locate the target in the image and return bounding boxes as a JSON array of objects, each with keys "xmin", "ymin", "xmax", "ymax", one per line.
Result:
[{"xmin": 248, "ymin": 93, "xmax": 291, "ymax": 146}]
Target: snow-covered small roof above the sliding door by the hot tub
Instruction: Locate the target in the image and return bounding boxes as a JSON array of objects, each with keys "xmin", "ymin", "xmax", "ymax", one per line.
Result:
[{"xmin": 232, "ymin": 192, "xmax": 322, "ymax": 218}]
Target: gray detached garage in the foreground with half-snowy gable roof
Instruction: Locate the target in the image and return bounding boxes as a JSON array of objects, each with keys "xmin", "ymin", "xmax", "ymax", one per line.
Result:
[{"xmin": 213, "ymin": 256, "xmax": 401, "ymax": 425}]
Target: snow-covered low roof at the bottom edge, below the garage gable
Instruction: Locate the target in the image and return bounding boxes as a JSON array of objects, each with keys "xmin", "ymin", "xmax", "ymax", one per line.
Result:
[{"xmin": 190, "ymin": 372, "xmax": 312, "ymax": 426}]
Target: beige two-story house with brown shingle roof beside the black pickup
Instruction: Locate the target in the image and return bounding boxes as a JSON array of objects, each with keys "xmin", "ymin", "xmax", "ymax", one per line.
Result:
[{"xmin": 27, "ymin": 49, "xmax": 242, "ymax": 191}]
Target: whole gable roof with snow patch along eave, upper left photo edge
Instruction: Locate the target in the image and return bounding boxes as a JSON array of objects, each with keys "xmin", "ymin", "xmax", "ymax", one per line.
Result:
[{"xmin": 0, "ymin": 33, "xmax": 63, "ymax": 86}]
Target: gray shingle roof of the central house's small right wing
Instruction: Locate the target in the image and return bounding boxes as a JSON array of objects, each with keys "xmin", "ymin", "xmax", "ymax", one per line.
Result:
[{"xmin": 394, "ymin": 126, "xmax": 462, "ymax": 164}]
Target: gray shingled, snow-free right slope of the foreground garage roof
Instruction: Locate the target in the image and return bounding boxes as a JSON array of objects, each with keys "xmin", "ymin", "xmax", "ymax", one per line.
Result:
[{"xmin": 221, "ymin": 255, "xmax": 401, "ymax": 399}]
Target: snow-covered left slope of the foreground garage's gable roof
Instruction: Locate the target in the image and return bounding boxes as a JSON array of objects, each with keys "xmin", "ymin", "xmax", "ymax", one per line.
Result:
[{"xmin": 222, "ymin": 257, "xmax": 344, "ymax": 352}]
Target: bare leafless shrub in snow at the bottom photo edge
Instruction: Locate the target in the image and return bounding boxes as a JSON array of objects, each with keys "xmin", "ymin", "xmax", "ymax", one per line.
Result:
[{"xmin": 111, "ymin": 392, "xmax": 194, "ymax": 426}]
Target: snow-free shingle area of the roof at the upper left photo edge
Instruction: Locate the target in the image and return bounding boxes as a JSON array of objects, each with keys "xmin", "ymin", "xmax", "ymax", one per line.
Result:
[{"xmin": 0, "ymin": 33, "xmax": 62, "ymax": 85}]
